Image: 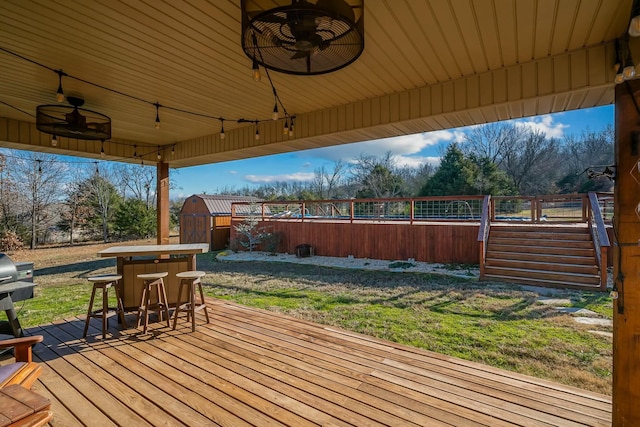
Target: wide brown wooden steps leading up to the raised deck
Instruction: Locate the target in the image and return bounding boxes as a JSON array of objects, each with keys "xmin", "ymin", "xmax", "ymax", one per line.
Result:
[{"xmin": 483, "ymin": 223, "xmax": 600, "ymax": 290}]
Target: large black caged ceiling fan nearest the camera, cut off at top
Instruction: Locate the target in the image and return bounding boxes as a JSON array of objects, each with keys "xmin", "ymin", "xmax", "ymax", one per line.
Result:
[{"xmin": 241, "ymin": 0, "xmax": 364, "ymax": 75}]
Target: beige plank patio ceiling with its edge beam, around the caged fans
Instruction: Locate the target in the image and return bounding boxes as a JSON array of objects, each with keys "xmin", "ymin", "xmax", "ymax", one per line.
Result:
[{"xmin": 0, "ymin": 0, "xmax": 632, "ymax": 167}]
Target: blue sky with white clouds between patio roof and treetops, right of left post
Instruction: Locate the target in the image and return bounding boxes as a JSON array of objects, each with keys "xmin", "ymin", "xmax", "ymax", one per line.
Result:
[{"xmin": 170, "ymin": 105, "xmax": 614, "ymax": 199}]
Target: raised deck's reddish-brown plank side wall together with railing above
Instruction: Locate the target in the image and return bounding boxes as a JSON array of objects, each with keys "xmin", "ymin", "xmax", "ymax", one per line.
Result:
[{"xmin": 231, "ymin": 193, "xmax": 613, "ymax": 271}]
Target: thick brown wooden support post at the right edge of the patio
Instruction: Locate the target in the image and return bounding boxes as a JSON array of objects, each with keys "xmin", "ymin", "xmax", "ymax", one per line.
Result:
[{"xmin": 612, "ymin": 80, "xmax": 640, "ymax": 427}]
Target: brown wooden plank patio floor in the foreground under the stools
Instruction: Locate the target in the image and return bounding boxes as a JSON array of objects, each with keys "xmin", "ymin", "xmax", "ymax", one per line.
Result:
[{"xmin": 15, "ymin": 299, "xmax": 611, "ymax": 427}]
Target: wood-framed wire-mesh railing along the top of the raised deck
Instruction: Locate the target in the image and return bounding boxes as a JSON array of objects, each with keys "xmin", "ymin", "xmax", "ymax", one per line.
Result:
[{"xmin": 231, "ymin": 193, "xmax": 613, "ymax": 227}]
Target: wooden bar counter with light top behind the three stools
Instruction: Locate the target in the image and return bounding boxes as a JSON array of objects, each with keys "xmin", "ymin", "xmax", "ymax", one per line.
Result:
[{"xmin": 98, "ymin": 243, "xmax": 209, "ymax": 310}]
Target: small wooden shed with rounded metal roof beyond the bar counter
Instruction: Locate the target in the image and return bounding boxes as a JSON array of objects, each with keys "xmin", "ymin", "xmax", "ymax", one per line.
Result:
[{"xmin": 180, "ymin": 194, "xmax": 261, "ymax": 250}]
